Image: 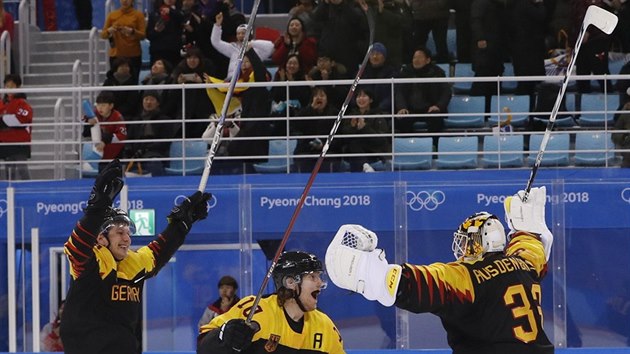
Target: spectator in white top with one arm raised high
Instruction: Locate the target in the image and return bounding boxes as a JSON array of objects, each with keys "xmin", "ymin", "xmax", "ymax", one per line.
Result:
[{"xmin": 210, "ymin": 13, "xmax": 273, "ymax": 80}]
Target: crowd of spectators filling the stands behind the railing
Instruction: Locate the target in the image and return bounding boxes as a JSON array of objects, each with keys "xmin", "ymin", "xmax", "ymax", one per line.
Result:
[{"xmin": 4, "ymin": 0, "xmax": 630, "ymax": 175}]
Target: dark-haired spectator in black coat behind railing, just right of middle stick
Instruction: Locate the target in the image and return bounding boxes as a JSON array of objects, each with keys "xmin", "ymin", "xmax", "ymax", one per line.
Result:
[{"xmin": 339, "ymin": 88, "xmax": 391, "ymax": 172}]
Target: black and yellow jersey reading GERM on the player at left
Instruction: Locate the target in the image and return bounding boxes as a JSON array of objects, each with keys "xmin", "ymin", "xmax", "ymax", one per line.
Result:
[{"xmin": 61, "ymin": 215, "xmax": 186, "ymax": 354}]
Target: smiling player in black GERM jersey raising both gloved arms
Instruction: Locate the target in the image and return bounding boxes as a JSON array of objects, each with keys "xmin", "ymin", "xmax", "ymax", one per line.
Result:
[{"xmin": 60, "ymin": 159, "xmax": 211, "ymax": 354}]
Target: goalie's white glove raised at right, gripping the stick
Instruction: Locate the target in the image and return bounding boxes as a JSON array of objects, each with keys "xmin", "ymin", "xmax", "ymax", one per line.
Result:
[{"xmin": 503, "ymin": 186, "xmax": 553, "ymax": 260}]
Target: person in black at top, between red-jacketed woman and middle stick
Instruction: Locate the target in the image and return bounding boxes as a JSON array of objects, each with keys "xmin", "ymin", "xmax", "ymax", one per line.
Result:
[{"xmin": 313, "ymin": 0, "xmax": 369, "ymax": 77}]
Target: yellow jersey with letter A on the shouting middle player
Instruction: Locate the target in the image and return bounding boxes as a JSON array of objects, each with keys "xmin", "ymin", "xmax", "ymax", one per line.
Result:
[{"xmin": 197, "ymin": 294, "xmax": 345, "ymax": 354}]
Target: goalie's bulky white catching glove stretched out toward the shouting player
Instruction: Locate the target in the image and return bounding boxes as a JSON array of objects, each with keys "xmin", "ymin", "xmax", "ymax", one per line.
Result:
[{"xmin": 326, "ymin": 225, "xmax": 402, "ymax": 306}]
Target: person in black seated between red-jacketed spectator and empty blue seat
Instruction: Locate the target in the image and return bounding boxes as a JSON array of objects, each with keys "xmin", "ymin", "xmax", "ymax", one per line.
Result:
[{"xmin": 124, "ymin": 90, "xmax": 175, "ymax": 176}]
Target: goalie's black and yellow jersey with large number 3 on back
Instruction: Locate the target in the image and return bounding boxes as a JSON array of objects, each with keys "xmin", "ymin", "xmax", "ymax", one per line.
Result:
[{"xmin": 396, "ymin": 232, "xmax": 554, "ymax": 354}]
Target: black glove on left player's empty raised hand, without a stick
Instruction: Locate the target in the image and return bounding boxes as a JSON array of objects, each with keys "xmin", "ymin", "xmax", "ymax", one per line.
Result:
[{"xmin": 85, "ymin": 159, "xmax": 125, "ymax": 211}]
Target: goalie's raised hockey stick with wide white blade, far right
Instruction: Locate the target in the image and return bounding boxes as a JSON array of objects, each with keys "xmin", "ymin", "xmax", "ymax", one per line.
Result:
[{"xmin": 523, "ymin": 5, "xmax": 618, "ymax": 202}]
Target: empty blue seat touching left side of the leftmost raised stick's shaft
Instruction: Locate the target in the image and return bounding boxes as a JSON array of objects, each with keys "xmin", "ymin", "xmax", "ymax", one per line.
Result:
[{"xmin": 164, "ymin": 141, "xmax": 208, "ymax": 175}]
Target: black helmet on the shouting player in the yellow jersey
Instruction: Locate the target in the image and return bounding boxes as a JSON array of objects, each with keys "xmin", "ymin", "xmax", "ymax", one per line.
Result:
[{"xmin": 272, "ymin": 251, "xmax": 324, "ymax": 289}]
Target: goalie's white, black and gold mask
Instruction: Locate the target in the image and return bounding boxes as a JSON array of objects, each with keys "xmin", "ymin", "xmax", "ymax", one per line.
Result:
[{"xmin": 453, "ymin": 211, "xmax": 505, "ymax": 261}]
